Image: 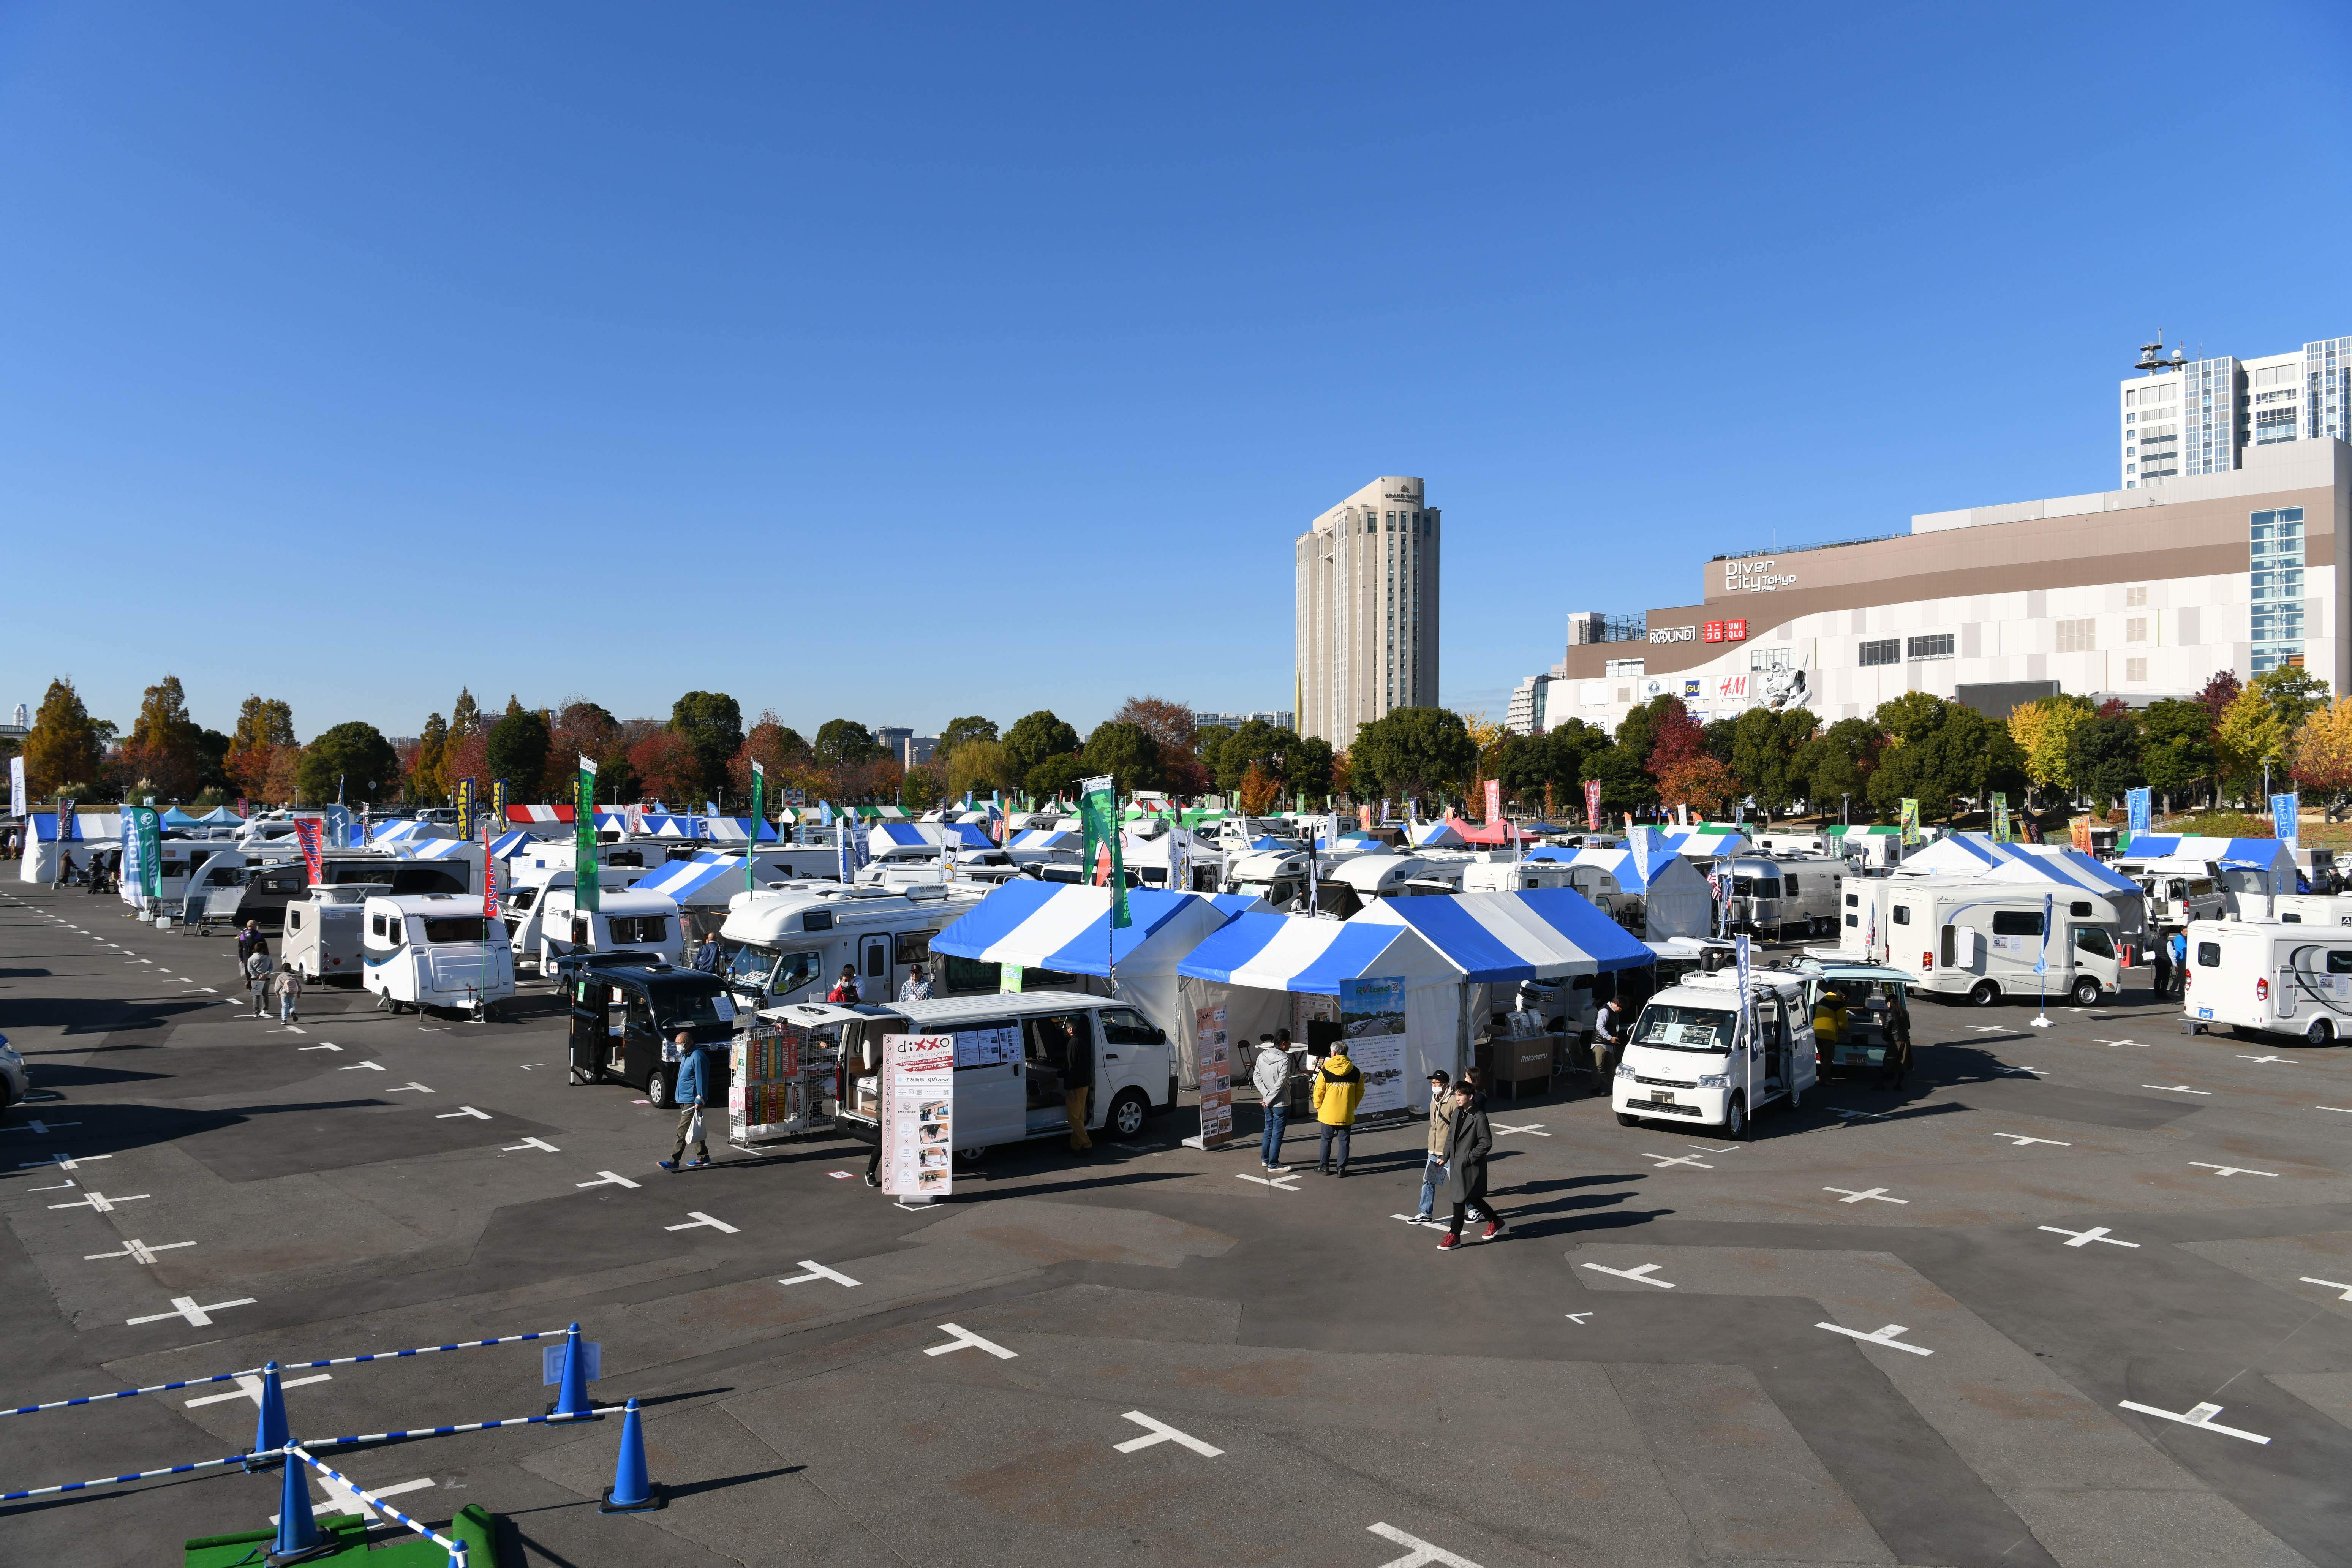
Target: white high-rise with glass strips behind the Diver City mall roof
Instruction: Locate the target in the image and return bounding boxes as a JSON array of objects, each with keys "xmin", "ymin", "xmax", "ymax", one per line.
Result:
[{"xmin": 2117, "ymin": 338, "xmax": 2352, "ymax": 489}]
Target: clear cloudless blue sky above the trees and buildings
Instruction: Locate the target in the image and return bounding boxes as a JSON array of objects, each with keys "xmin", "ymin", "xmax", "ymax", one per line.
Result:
[{"xmin": 0, "ymin": 2, "xmax": 2352, "ymax": 736}]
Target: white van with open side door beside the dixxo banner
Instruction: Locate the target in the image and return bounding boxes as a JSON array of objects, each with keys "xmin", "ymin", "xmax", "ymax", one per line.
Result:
[{"xmin": 837, "ymin": 992, "xmax": 1176, "ymax": 1161}]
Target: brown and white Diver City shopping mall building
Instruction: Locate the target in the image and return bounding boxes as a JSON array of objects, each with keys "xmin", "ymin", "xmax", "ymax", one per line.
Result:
[{"xmin": 1510, "ymin": 437, "xmax": 2352, "ymax": 731}]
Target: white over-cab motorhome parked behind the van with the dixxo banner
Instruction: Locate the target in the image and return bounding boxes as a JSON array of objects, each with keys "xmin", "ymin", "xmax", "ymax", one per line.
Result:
[{"xmin": 720, "ymin": 882, "xmax": 988, "ymax": 1008}]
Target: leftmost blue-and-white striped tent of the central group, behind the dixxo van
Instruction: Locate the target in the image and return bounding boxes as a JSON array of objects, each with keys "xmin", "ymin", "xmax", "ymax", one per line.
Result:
[{"xmin": 931, "ymin": 879, "xmax": 1279, "ymax": 1053}]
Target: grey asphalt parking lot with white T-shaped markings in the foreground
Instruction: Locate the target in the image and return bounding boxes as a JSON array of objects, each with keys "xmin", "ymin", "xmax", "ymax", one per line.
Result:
[{"xmin": 0, "ymin": 882, "xmax": 2352, "ymax": 1568}]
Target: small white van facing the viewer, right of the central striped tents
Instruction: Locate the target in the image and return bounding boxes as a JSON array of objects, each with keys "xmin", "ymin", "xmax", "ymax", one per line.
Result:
[{"xmin": 1609, "ymin": 969, "xmax": 1816, "ymax": 1140}]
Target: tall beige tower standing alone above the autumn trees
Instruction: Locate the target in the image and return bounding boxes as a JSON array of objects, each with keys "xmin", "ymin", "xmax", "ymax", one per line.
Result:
[{"xmin": 1294, "ymin": 477, "xmax": 1444, "ymax": 750}]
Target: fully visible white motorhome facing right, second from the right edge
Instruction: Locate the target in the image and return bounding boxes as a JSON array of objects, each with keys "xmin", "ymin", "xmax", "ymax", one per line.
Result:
[{"xmin": 1839, "ymin": 877, "xmax": 2124, "ymax": 1006}]
